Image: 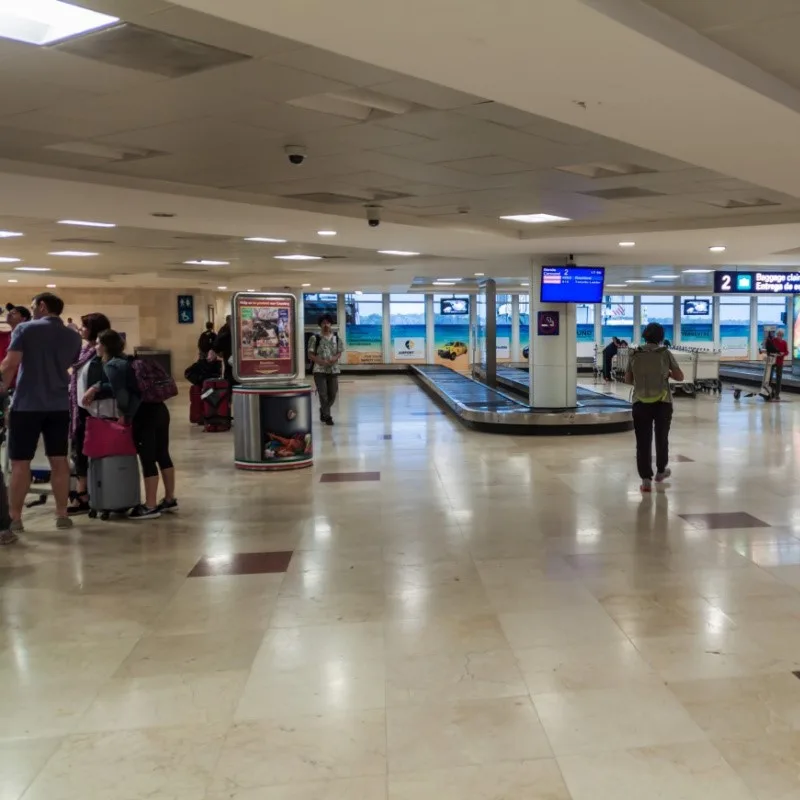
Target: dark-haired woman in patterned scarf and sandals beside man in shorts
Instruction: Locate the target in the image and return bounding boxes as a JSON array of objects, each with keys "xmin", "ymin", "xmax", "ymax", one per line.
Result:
[{"xmin": 67, "ymin": 312, "xmax": 111, "ymax": 517}]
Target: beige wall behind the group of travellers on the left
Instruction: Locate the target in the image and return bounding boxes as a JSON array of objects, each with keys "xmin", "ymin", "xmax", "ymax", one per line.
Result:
[{"xmin": 4, "ymin": 288, "xmax": 230, "ymax": 376}]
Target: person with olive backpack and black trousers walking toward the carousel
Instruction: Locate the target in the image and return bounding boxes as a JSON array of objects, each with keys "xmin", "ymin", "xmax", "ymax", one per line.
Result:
[{"xmin": 625, "ymin": 322, "xmax": 683, "ymax": 492}]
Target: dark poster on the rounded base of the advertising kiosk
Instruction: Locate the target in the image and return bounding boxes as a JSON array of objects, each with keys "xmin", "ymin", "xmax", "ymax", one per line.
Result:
[{"xmin": 260, "ymin": 394, "xmax": 313, "ymax": 465}]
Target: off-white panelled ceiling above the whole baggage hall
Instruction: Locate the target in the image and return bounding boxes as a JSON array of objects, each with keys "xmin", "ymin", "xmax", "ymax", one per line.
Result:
[{"xmin": 0, "ymin": 0, "xmax": 800, "ymax": 289}]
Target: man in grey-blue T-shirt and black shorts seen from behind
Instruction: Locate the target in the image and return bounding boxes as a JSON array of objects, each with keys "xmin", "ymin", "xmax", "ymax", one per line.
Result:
[{"xmin": 0, "ymin": 292, "xmax": 81, "ymax": 533}]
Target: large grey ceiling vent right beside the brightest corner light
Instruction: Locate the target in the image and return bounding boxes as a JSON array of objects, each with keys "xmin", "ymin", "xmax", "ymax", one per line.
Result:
[{"xmin": 50, "ymin": 22, "xmax": 250, "ymax": 78}]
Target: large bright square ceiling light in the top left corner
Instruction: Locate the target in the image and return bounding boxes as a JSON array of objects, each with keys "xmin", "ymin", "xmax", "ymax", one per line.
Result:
[{"xmin": 0, "ymin": 0, "xmax": 119, "ymax": 45}]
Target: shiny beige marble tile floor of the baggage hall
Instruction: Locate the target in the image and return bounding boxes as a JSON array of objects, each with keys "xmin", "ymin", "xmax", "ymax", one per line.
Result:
[{"xmin": 0, "ymin": 377, "xmax": 800, "ymax": 800}]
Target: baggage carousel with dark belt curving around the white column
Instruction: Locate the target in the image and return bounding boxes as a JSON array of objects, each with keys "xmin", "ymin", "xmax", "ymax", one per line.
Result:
[{"xmin": 411, "ymin": 365, "xmax": 633, "ymax": 436}]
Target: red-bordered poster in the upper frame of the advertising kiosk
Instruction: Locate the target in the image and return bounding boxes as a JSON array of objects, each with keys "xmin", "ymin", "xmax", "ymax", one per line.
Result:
[{"xmin": 235, "ymin": 293, "xmax": 297, "ymax": 381}]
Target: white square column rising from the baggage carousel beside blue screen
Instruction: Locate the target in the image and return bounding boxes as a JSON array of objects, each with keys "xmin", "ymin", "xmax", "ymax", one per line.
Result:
[{"xmin": 528, "ymin": 256, "xmax": 578, "ymax": 408}]
